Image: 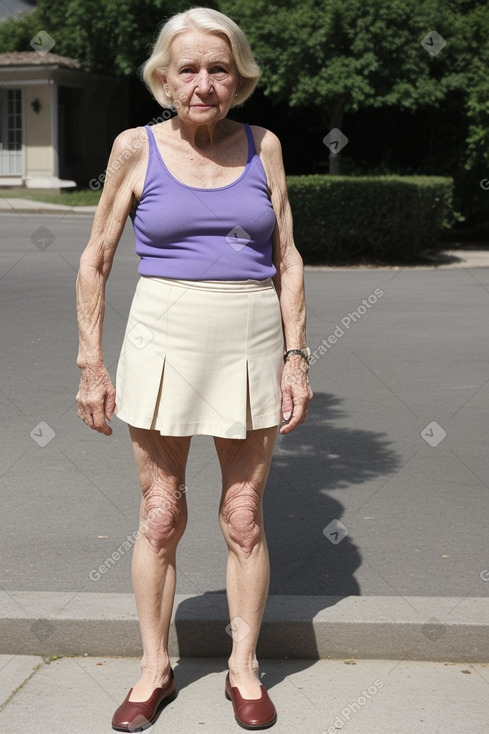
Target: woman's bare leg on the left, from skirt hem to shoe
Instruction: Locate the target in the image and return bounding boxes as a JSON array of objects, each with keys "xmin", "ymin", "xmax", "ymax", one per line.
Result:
[{"xmin": 129, "ymin": 426, "xmax": 190, "ymax": 701}]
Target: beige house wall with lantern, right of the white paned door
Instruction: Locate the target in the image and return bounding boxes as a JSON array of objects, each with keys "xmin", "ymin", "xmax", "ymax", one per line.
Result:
[{"xmin": 0, "ymin": 65, "xmax": 128, "ymax": 187}]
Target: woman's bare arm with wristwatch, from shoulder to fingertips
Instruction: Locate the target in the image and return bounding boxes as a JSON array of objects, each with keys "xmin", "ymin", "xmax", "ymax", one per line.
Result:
[{"xmin": 255, "ymin": 128, "xmax": 312, "ymax": 433}]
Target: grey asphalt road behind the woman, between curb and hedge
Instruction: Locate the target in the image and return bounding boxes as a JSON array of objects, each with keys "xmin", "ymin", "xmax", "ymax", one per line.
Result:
[{"xmin": 0, "ymin": 214, "xmax": 489, "ymax": 604}]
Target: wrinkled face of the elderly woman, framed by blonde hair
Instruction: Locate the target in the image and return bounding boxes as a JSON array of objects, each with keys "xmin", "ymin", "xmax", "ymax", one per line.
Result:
[{"xmin": 160, "ymin": 31, "xmax": 239, "ymax": 125}]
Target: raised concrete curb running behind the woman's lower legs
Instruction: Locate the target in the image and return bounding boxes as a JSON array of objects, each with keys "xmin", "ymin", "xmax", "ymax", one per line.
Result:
[{"xmin": 0, "ymin": 591, "xmax": 489, "ymax": 663}]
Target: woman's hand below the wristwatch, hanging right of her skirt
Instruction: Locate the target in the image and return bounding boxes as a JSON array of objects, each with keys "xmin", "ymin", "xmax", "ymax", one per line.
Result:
[{"xmin": 280, "ymin": 355, "xmax": 313, "ymax": 433}]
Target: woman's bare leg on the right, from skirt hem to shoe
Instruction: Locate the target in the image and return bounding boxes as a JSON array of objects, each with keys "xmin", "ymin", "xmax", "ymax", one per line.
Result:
[{"xmin": 214, "ymin": 426, "xmax": 277, "ymax": 699}]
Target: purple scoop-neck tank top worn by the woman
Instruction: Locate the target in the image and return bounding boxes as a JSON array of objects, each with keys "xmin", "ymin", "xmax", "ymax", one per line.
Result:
[{"xmin": 131, "ymin": 125, "xmax": 276, "ymax": 280}]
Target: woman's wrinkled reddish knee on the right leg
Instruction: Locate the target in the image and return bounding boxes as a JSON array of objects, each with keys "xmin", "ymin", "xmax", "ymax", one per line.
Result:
[{"xmin": 220, "ymin": 484, "xmax": 263, "ymax": 557}]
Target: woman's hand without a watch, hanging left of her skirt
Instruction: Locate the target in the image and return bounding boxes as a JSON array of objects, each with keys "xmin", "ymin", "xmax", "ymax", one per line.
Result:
[{"xmin": 76, "ymin": 364, "xmax": 115, "ymax": 436}]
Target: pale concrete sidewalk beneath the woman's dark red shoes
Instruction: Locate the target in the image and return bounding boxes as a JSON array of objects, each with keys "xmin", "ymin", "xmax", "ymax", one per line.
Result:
[{"xmin": 0, "ymin": 655, "xmax": 489, "ymax": 734}]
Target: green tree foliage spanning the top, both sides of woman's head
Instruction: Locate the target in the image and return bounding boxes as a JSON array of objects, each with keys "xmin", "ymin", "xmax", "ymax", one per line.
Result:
[{"xmin": 0, "ymin": 0, "xmax": 489, "ymax": 177}]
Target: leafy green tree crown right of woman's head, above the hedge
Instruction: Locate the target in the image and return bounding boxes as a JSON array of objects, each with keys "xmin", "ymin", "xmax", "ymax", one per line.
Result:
[{"xmin": 219, "ymin": 0, "xmax": 489, "ymax": 173}]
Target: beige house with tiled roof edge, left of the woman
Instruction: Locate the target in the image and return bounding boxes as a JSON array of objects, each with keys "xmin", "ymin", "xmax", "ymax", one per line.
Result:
[{"xmin": 0, "ymin": 51, "xmax": 127, "ymax": 189}]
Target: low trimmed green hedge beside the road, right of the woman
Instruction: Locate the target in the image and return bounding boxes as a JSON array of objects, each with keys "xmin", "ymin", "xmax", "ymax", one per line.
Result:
[{"xmin": 287, "ymin": 175, "xmax": 455, "ymax": 264}]
